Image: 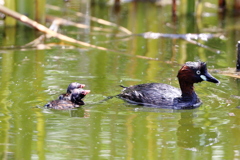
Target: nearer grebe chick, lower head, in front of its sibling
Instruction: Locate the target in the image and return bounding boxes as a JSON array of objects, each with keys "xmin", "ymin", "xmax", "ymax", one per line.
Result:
[{"xmin": 45, "ymin": 88, "xmax": 90, "ymax": 110}]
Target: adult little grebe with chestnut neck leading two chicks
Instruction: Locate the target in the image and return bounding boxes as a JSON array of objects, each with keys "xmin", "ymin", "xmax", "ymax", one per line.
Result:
[{"xmin": 118, "ymin": 62, "xmax": 220, "ymax": 109}]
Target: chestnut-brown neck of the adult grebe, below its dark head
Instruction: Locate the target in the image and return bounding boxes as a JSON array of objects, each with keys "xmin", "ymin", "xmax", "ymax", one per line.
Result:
[{"xmin": 178, "ymin": 79, "xmax": 197, "ymax": 101}]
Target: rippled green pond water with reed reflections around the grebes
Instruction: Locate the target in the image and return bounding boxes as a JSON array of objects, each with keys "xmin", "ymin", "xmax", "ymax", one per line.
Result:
[{"xmin": 0, "ymin": 1, "xmax": 240, "ymax": 160}]
